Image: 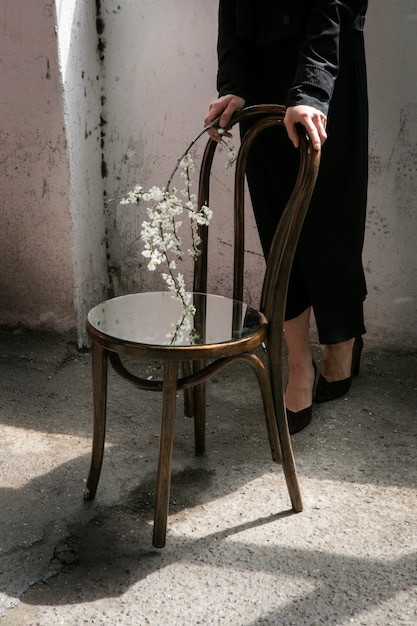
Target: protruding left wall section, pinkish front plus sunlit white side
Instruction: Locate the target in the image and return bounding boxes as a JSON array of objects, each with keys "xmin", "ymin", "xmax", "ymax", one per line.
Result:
[{"xmin": 0, "ymin": 0, "xmax": 108, "ymax": 344}]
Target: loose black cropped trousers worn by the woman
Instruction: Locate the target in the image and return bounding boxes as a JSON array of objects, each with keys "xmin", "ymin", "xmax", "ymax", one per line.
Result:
[{"xmin": 241, "ymin": 31, "xmax": 368, "ymax": 344}]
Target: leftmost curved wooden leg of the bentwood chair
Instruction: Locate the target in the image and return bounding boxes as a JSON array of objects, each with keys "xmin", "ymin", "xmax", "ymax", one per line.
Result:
[{"xmin": 84, "ymin": 342, "xmax": 108, "ymax": 500}]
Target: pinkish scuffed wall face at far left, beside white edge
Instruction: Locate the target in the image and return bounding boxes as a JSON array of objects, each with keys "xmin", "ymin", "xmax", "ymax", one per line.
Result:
[{"xmin": 0, "ymin": 0, "xmax": 75, "ymax": 331}]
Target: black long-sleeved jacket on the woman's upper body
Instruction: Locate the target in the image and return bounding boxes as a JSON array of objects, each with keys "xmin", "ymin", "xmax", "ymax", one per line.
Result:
[{"xmin": 217, "ymin": 0, "xmax": 368, "ymax": 114}]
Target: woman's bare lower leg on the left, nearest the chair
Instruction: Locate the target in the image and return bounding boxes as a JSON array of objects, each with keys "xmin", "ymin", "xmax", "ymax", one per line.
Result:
[{"xmin": 284, "ymin": 308, "xmax": 314, "ymax": 412}]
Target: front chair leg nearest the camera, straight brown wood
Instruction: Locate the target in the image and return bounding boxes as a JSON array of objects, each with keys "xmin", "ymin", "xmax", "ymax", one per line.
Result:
[{"xmin": 152, "ymin": 361, "xmax": 178, "ymax": 548}]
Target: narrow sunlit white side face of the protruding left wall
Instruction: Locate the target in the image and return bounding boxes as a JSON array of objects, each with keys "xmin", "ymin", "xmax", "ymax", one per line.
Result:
[{"xmin": 56, "ymin": 0, "xmax": 109, "ymax": 344}]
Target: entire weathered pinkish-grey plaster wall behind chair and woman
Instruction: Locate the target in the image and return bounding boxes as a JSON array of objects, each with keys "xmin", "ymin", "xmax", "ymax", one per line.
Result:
[{"xmin": 0, "ymin": 0, "xmax": 417, "ymax": 349}]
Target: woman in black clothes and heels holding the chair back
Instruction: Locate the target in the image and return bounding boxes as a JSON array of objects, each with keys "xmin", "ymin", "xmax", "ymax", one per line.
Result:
[{"xmin": 205, "ymin": 0, "xmax": 368, "ymax": 433}]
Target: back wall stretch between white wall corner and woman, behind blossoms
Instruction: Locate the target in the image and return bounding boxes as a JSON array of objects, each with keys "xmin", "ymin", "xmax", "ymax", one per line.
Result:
[{"xmin": 104, "ymin": 0, "xmax": 264, "ymax": 301}]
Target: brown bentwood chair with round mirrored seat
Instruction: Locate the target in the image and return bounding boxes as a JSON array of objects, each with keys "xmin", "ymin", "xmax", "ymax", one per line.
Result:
[{"xmin": 85, "ymin": 105, "xmax": 320, "ymax": 548}]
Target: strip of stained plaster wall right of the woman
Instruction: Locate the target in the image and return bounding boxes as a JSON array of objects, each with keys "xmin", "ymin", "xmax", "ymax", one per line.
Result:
[{"xmin": 364, "ymin": 0, "xmax": 417, "ymax": 348}]
